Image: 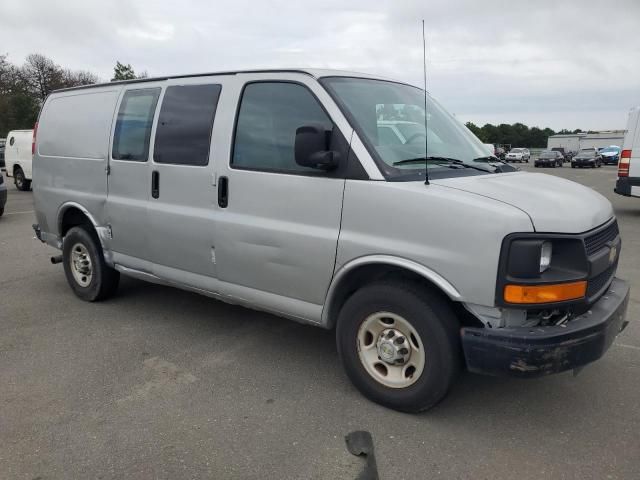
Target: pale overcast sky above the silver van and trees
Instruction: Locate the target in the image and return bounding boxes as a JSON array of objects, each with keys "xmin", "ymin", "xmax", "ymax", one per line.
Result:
[{"xmin": 0, "ymin": 0, "xmax": 640, "ymax": 129}]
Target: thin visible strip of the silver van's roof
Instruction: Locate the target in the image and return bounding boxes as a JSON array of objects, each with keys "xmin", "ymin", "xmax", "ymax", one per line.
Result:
[{"xmin": 52, "ymin": 68, "xmax": 406, "ymax": 93}]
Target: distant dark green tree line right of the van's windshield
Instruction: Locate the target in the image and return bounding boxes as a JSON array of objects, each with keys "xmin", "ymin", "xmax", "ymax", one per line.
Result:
[{"xmin": 465, "ymin": 122, "xmax": 590, "ymax": 148}]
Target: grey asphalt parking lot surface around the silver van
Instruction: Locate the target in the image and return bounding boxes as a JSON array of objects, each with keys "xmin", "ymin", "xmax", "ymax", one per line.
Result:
[{"xmin": 0, "ymin": 162, "xmax": 640, "ymax": 479}]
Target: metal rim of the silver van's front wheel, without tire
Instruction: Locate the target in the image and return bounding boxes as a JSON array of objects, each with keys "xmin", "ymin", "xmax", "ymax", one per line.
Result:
[{"xmin": 357, "ymin": 312, "xmax": 426, "ymax": 388}]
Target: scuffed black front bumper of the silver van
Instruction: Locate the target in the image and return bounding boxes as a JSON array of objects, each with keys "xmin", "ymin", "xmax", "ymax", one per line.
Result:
[{"xmin": 461, "ymin": 278, "xmax": 629, "ymax": 377}]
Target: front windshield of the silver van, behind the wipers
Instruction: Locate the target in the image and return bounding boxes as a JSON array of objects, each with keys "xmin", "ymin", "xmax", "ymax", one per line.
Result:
[{"xmin": 320, "ymin": 77, "xmax": 490, "ymax": 180}]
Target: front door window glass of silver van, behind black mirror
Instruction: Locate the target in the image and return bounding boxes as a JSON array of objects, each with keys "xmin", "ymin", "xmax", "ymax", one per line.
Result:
[{"xmin": 231, "ymin": 82, "xmax": 333, "ymax": 174}]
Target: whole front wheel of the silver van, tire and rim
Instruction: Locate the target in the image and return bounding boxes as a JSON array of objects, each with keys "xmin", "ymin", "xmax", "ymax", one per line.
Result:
[{"xmin": 336, "ymin": 282, "xmax": 461, "ymax": 412}]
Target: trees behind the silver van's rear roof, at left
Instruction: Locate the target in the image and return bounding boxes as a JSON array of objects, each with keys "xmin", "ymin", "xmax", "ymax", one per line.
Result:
[{"xmin": 0, "ymin": 53, "xmax": 147, "ymax": 138}]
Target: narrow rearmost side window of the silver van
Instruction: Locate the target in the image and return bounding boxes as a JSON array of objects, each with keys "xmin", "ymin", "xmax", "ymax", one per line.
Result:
[{"xmin": 111, "ymin": 88, "xmax": 160, "ymax": 162}]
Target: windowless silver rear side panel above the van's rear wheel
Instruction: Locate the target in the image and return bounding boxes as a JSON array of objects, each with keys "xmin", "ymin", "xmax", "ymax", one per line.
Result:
[{"xmin": 33, "ymin": 86, "xmax": 121, "ymax": 235}]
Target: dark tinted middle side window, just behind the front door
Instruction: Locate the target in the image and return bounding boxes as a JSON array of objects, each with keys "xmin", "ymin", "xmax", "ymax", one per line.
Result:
[{"xmin": 153, "ymin": 85, "xmax": 221, "ymax": 166}]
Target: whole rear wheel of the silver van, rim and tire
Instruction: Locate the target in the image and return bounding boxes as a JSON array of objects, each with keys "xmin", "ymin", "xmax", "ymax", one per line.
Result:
[{"xmin": 62, "ymin": 226, "xmax": 120, "ymax": 302}]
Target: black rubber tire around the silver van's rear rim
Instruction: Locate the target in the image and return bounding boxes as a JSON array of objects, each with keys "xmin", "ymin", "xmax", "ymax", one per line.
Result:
[{"xmin": 62, "ymin": 226, "xmax": 120, "ymax": 302}]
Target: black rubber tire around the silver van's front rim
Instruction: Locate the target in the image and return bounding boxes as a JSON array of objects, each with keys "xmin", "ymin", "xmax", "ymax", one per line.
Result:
[{"xmin": 336, "ymin": 282, "xmax": 462, "ymax": 412}]
